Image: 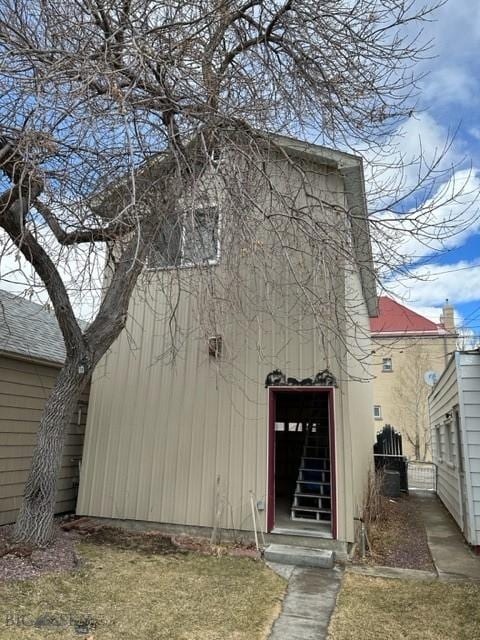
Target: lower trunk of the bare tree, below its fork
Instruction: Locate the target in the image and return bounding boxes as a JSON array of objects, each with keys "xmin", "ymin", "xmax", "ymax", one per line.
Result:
[{"xmin": 14, "ymin": 358, "xmax": 88, "ymax": 546}]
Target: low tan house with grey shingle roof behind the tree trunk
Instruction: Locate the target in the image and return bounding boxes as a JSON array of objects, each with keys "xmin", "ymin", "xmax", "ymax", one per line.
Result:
[{"xmin": 0, "ymin": 290, "xmax": 88, "ymax": 525}]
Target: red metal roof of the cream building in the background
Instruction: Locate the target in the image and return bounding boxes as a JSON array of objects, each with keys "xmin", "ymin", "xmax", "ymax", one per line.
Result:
[{"xmin": 370, "ymin": 296, "xmax": 447, "ymax": 334}]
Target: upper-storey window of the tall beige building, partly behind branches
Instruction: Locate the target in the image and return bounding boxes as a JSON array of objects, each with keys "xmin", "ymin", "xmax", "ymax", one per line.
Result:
[{"xmin": 148, "ymin": 207, "xmax": 220, "ymax": 269}]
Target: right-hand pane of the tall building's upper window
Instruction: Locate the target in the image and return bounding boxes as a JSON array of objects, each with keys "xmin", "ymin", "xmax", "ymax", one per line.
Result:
[{"xmin": 183, "ymin": 207, "xmax": 218, "ymax": 264}]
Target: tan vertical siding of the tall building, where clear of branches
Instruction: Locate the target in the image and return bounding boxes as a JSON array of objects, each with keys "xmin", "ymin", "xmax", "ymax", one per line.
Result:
[{"xmin": 77, "ymin": 154, "xmax": 371, "ymax": 540}]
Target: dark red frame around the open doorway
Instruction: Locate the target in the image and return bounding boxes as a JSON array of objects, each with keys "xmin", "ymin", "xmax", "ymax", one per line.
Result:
[{"xmin": 267, "ymin": 386, "xmax": 337, "ymax": 539}]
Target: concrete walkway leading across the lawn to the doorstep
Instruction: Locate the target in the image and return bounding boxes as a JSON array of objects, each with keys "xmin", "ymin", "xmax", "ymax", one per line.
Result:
[{"xmin": 268, "ymin": 563, "xmax": 342, "ymax": 640}]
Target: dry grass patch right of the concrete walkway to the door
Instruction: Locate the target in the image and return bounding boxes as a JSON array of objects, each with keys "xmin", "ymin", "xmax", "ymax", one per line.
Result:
[{"xmin": 328, "ymin": 573, "xmax": 480, "ymax": 640}]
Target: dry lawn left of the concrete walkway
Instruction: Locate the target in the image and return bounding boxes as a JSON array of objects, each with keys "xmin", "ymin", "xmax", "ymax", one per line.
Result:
[{"xmin": 0, "ymin": 543, "xmax": 286, "ymax": 640}]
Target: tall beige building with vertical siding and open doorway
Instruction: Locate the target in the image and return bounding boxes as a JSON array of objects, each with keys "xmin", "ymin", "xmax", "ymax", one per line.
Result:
[{"xmin": 77, "ymin": 136, "xmax": 376, "ymax": 543}]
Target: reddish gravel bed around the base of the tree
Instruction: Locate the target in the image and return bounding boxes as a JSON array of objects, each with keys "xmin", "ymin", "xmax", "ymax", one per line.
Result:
[{"xmin": 0, "ymin": 526, "xmax": 79, "ymax": 581}]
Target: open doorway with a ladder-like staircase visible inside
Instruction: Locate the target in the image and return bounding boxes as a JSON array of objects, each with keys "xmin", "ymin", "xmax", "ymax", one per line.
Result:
[{"xmin": 268, "ymin": 387, "xmax": 335, "ymax": 537}]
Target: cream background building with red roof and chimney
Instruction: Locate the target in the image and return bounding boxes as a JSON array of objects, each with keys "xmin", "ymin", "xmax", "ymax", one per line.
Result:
[{"xmin": 370, "ymin": 296, "xmax": 457, "ymax": 460}]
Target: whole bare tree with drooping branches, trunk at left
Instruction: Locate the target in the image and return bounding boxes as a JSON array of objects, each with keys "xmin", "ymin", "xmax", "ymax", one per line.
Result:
[{"xmin": 0, "ymin": 0, "xmax": 468, "ymax": 544}]
